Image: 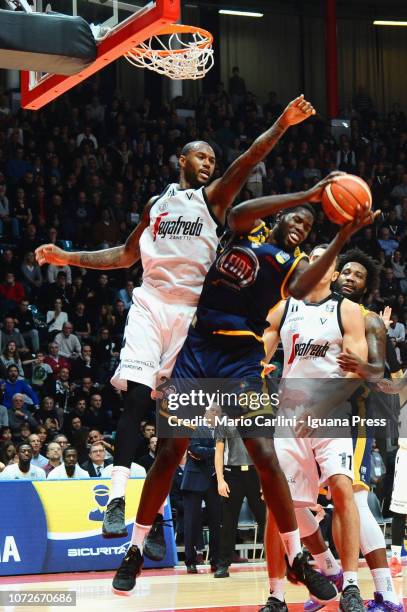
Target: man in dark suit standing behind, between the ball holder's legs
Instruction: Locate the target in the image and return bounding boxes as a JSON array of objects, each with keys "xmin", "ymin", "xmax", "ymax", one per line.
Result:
[{"xmin": 181, "ymin": 410, "xmax": 221, "ymax": 574}]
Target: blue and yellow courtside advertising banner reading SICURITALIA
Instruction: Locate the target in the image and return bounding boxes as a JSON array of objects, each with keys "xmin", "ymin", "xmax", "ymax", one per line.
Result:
[{"xmin": 0, "ymin": 478, "xmax": 177, "ymax": 576}]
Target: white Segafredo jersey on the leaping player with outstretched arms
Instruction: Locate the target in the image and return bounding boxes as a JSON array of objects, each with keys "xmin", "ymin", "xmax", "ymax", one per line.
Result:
[{"xmin": 140, "ymin": 183, "xmax": 219, "ymax": 305}]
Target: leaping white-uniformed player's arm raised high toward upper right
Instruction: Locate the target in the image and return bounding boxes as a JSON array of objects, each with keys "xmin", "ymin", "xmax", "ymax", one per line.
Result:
[{"xmin": 206, "ymin": 95, "xmax": 315, "ymax": 220}]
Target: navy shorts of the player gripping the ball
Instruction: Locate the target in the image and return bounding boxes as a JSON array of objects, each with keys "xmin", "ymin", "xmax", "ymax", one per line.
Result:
[{"xmin": 158, "ymin": 327, "xmax": 277, "ymax": 437}]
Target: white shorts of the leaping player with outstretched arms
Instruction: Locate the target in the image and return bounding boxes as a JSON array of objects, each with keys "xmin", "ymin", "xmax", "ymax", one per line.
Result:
[{"xmin": 111, "ymin": 287, "xmax": 196, "ymax": 391}]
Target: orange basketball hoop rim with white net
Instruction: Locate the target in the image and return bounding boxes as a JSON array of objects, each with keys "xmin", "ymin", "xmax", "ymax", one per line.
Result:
[{"xmin": 124, "ymin": 23, "xmax": 214, "ymax": 80}]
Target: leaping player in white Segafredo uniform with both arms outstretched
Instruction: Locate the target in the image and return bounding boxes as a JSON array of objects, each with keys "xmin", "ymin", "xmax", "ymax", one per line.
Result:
[{"xmin": 36, "ymin": 95, "xmax": 315, "ymax": 544}]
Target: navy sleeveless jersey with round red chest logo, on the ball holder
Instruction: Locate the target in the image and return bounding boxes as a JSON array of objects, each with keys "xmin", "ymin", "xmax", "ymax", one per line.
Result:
[{"xmin": 195, "ymin": 223, "xmax": 306, "ymax": 340}]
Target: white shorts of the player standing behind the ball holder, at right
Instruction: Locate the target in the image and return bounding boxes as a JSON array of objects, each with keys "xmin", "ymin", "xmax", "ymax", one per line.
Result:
[{"xmin": 274, "ymin": 437, "xmax": 353, "ymax": 507}]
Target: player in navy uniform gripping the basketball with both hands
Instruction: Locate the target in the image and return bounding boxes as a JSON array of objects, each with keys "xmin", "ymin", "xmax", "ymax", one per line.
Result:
[{"xmin": 113, "ymin": 174, "xmax": 380, "ymax": 602}]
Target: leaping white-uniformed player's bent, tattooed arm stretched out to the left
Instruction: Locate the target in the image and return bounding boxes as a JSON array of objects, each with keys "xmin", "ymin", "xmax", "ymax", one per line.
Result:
[{"xmin": 35, "ymin": 201, "xmax": 153, "ymax": 270}]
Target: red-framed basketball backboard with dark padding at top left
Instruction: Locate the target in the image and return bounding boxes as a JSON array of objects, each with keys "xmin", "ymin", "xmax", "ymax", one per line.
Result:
[{"xmin": 21, "ymin": 0, "xmax": 180, "ymax": 110}]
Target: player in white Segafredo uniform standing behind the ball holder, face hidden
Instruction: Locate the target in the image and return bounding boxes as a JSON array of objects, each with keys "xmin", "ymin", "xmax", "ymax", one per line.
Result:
[{"xmin": 264, "ymin": 245, "xmax": 367, "ymax": 612}]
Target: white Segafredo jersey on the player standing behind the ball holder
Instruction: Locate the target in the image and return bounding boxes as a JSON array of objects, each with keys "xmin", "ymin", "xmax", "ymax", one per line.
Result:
[{"xmin": 280, "ymin": 295, "xmax": 343, "ymax": 378}]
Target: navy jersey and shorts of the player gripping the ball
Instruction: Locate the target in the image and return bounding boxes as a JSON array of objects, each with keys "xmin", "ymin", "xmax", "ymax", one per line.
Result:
[{"xmin": 168, "ymin": 223, "xmax": 305, "ymax": 426}]
